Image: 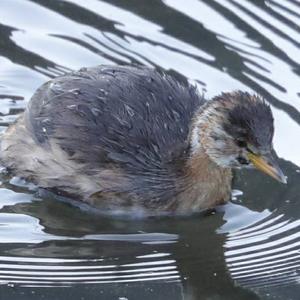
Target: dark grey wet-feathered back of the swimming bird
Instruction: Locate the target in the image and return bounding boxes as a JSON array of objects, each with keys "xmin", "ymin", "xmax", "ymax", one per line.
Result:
[{"xmin": 1, "ymin": 66, "xmax": 203, "ymax": 211}]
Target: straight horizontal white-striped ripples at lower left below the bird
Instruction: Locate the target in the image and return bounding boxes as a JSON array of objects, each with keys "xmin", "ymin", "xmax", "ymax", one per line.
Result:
[{"xmin": 0, "ymin": 253, "xmax": 180, "ymax": 287}]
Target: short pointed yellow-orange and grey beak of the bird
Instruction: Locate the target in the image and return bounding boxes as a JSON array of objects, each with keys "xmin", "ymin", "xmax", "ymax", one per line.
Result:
[{"xmin": 248, "ymin": 150, "xmax": 287, "ymax": 184}]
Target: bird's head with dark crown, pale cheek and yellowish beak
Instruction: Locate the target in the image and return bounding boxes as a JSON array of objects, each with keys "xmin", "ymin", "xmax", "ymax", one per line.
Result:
[{"xmin": 191, "ymin": 91, "xmax": 286, "ymax": 183}]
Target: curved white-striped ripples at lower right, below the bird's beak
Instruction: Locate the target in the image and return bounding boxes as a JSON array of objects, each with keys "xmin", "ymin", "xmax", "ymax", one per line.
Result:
[{"xmin": 221, "ymin": 204, "xmax": 300, "ymax": 294}]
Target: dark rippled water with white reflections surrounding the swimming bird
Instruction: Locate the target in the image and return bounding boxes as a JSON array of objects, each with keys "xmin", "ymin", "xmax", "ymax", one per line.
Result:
[{"xmin": 0, "ymin": 0, "xmax": 300, "ymax": 300}]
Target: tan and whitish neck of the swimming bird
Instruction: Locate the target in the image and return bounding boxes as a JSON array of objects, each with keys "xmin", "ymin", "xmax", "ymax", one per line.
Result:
[{"xmin": 173, "ymin": 101, "xmax": 231, "ymax": 209}]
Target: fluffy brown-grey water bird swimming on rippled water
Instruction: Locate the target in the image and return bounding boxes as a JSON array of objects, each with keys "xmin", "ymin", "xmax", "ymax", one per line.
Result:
[{"xmin": 1, "ymin": 66, "xmax": 286, "ymax": 215}]
